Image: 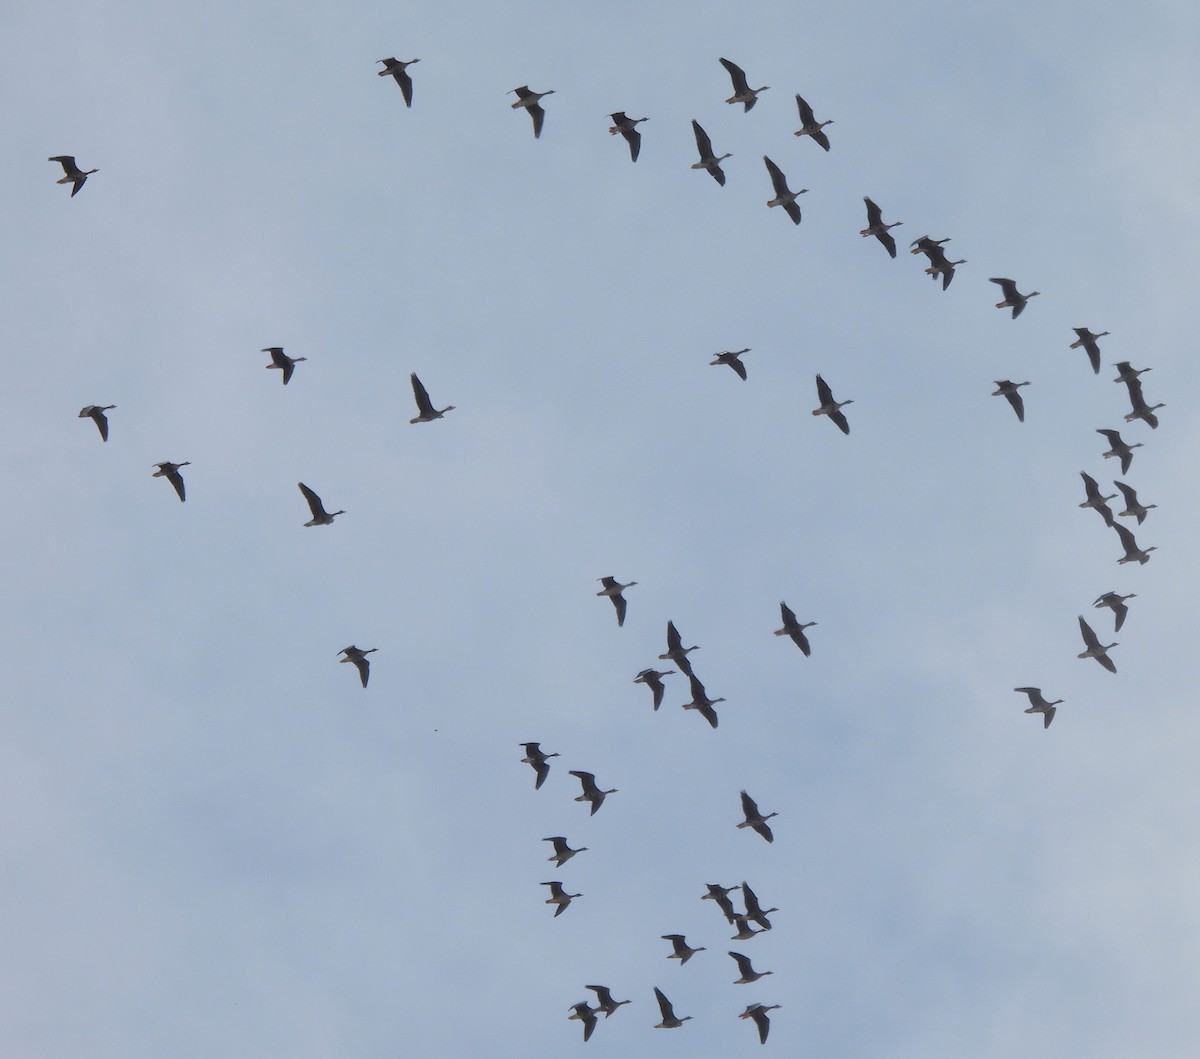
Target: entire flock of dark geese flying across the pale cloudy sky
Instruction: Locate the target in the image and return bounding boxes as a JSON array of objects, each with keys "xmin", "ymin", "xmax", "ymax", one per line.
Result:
[{"xmin": 38, "ymin": 20, "xmax": 1180, "ymax": 1045}]
